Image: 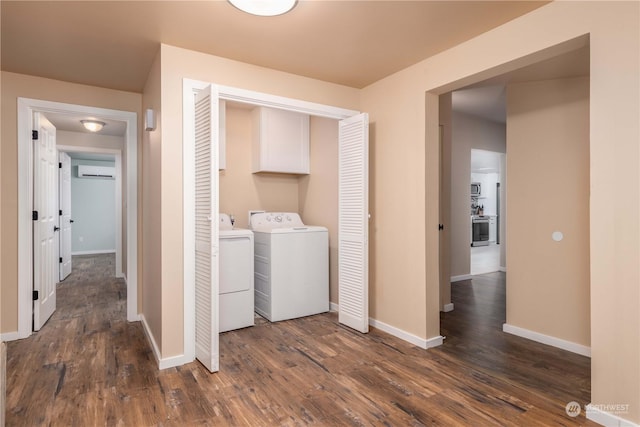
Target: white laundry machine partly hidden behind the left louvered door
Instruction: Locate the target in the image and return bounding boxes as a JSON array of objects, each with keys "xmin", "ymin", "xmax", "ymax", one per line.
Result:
[{"xmin": 219, "ymin": 213, "xmax": 255, "ymax": 332}]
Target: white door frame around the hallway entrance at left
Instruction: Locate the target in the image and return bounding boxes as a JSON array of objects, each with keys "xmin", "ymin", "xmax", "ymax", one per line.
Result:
[{"xmin": 17, "ymin": 98, "xmax": 139, "ymax": 339}]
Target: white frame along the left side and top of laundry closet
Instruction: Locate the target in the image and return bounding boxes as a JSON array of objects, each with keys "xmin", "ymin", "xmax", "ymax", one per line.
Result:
[{"xmin": 181, "ymin": 79, "xmax": 360, "ymax": 367}]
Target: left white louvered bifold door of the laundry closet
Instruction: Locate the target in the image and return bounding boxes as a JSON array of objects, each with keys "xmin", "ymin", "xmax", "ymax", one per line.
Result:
[{"xmin": 195, "ymin": 86, "xmax": 219, "ymax": 372}]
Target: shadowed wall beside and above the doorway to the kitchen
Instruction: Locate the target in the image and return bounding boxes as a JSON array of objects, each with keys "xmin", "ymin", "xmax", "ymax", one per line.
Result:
[{"xmin": 451, "ymin": 111, "xmax": 506, "ymax": 276}]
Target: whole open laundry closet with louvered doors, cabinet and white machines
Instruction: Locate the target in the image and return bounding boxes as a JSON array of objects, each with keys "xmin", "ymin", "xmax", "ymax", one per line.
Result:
[{"xmin": 188, "ymin": 80, "xmax": 369, "ymax": 372}]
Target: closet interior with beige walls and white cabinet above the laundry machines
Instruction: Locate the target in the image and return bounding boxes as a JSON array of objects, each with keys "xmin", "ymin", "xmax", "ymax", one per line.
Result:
[{"xmin": 219, "ymin": 101, "xmax": 338, "ymax": 320}]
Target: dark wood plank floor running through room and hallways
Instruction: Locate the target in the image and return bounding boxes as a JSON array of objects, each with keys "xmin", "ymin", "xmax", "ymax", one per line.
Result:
[{"xmin": 6, "ymin": 256, "xmax": 595, "ymax": 426}]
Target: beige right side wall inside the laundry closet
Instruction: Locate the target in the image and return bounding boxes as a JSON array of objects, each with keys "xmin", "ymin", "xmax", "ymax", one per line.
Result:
[{"xmin": 298, "ymin": 117, "xmax": 339, "ymax": 304}]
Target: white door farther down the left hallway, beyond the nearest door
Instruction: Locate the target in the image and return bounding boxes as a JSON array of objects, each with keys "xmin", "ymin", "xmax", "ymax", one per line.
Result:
[{"xmin": 58, "ymin": 153, "xmax": 72, "ymax": 281}]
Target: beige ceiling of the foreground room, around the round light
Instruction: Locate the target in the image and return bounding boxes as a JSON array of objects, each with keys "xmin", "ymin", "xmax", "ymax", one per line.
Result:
[{"xmin": 0, "ymin": 0, "xmax": 548, "ymax": 93}]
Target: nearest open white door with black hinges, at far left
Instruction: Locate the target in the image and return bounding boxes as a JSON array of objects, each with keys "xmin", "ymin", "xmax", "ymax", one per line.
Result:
[{"xmin": 33, "ymin": 113, "xmax": 58, "ymax": 331}]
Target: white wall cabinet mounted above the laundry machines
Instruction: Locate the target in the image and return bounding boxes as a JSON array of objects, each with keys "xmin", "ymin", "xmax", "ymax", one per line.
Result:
[{"xmin": 252, "ymin": 107, "xmax": 309, "ymax": 174}]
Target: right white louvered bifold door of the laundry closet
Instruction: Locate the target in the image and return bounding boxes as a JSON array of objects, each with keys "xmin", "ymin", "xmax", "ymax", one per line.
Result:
[{"xmin": 338, "ymin": 113, "xmax": 369, "ymax": 332}]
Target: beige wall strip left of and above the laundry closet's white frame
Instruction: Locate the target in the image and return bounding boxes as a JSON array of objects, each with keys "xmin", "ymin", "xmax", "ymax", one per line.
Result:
[{"xmin": 155, "ymin": 45, "xmax": 359, "ymax": 358}]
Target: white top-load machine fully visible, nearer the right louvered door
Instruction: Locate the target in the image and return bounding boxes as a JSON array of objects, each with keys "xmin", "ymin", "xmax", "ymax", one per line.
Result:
[{"xmin": 250, "ymin": 212, "xmax": 329, "ymax": 322}]
